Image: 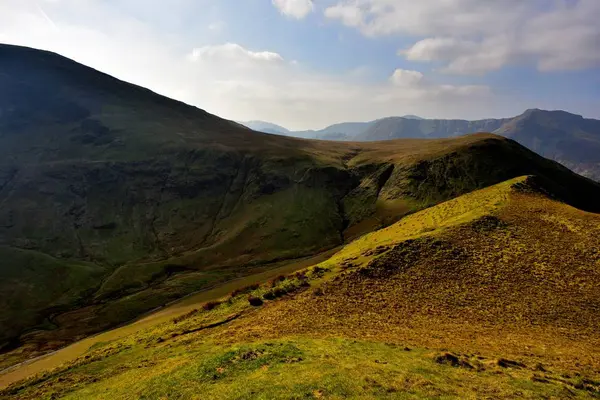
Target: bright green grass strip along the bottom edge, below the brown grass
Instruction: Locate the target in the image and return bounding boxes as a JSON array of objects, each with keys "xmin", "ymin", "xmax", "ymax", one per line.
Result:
[{"xmin": 5, "ymin": 337, "xmax": 592, "ymax": 399}]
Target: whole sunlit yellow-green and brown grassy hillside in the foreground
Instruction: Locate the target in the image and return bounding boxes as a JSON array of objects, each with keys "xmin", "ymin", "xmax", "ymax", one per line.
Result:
[{"xmin": 0, "ymin": 177, "xmax": 600, "ymax": 399}]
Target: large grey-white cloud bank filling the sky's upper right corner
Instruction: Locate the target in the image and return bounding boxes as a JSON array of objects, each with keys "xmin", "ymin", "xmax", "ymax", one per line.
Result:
[{"xmin": 325, "ymin": 0, "xmax": 600, "ymax": 74}]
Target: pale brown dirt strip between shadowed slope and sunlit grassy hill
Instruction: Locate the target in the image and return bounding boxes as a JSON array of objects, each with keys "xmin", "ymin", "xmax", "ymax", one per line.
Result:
[{"xmin": 0, "ymin": 247, "xmax": 340, "ymax": 388}]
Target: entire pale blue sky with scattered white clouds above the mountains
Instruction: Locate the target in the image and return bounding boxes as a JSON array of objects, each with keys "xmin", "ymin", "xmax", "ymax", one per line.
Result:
[{"xmin": 0, "ymin": 0, "xmax": 600, "ymax": 130}]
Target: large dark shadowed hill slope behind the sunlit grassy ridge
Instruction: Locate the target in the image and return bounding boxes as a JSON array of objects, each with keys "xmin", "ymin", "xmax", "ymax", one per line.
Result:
[{"xmin": 0, "ymin": 46, "xmax": 600, "ymax": 365}]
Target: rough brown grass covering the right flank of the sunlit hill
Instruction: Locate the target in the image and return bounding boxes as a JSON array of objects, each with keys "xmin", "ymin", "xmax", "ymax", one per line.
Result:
[{"xmin": 218, "ymin": 189, "xmax": 600, "ymax": 373}]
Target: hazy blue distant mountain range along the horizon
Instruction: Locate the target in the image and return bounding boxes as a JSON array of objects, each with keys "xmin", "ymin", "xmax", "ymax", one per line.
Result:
[{"xmin": 242, "ymin": 109, "xmax": 600, "ymax": 181}]
